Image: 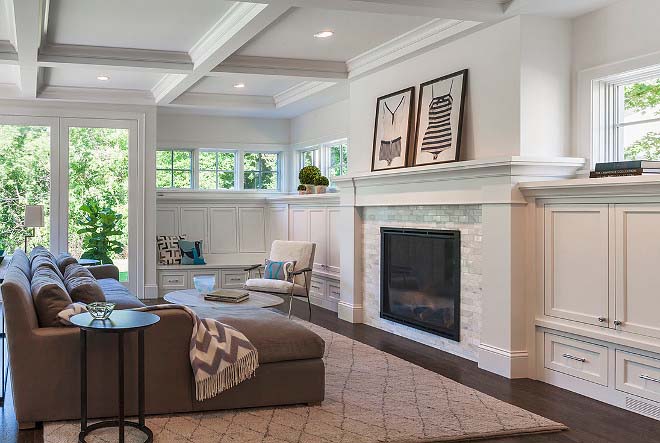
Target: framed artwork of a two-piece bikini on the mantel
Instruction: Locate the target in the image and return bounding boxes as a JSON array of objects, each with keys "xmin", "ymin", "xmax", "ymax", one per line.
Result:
[{"xmin": 371, "ymin": 87, "xmax": 415, "ymax": 171}]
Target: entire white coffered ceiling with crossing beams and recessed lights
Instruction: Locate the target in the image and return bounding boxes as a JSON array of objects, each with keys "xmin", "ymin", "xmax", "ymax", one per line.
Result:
[{"xmin": 0, "ymin": 0, "xmax": 610, "ymax": 118}]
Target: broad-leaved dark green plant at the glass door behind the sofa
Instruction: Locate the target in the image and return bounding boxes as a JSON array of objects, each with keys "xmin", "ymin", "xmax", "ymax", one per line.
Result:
[{"xmin": 76, "ymin": 200, "xmax": 124, "ymax": 264}]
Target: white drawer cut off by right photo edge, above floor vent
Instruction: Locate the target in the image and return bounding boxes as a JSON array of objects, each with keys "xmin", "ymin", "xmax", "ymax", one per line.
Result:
[{"xmin": 616, "ymin": 349, "xmax": 660, "ymax": 402}]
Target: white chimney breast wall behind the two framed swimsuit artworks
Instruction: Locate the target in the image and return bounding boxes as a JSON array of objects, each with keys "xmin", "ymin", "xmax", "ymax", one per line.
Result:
[{"xmin": 349, "ymin": 17, "xmax": 520, "ymax": 173}]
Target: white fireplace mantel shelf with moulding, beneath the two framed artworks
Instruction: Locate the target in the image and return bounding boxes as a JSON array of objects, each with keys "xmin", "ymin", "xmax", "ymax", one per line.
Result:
[{"xmin": 335, "ymin": 157, "xmax": 585, "ymax": 207}]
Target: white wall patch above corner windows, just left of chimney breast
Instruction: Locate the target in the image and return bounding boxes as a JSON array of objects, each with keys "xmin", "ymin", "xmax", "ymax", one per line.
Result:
[{"xmin": 291, "ymin": 100, "xmax": 350, "ymax": 149}]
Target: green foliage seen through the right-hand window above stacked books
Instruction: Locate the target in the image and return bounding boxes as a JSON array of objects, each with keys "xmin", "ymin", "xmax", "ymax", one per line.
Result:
[{"xmin": 624, "ymin": 79, "xmax": 660, "ymax": 160}]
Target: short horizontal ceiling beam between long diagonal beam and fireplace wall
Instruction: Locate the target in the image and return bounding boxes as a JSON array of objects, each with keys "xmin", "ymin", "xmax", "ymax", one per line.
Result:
[{"xmin": 208, "ymin": 55, "xmax": 348, "ymax": 80}]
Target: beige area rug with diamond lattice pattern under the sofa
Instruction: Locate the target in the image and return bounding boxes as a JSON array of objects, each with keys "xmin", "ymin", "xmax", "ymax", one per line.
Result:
[{"xmin": 44, "ymin": 322, "xmax": 566, "ymax": 443}]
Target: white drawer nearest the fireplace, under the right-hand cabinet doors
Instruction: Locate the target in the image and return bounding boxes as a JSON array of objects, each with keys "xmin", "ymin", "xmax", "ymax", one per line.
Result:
[{"xmin": 544, "ymin": 332, "xmax": 607, "ymax": 386}]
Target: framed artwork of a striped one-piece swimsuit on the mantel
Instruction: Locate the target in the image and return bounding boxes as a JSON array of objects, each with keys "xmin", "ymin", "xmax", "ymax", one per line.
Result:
[{"xmin": 413, "ymin": 69, "xmax": 467, "ymax": 166}]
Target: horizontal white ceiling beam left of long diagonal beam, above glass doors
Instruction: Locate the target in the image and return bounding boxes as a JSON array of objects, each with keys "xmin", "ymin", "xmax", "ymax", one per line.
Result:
[{"xmin": 38, "ymin": 45, "xmax": 193, "ymax": 74}]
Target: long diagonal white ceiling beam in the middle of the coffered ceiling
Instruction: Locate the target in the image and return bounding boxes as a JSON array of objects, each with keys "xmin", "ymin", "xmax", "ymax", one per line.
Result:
[{"xmin": 152, "ymin": 2, "xmax": 289, "ymax": 105}]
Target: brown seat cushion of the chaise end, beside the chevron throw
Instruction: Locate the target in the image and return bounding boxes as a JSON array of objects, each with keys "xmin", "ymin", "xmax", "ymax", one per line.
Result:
[{"xmin": 209, "ymin": 309, "xmax": 325, "ymax": 364}]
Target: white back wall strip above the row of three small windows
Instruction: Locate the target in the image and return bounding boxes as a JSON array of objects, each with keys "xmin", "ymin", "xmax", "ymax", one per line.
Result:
[{"xmin": 158, "ymin": 112, "xmax": 290, "ymax": 149}]
